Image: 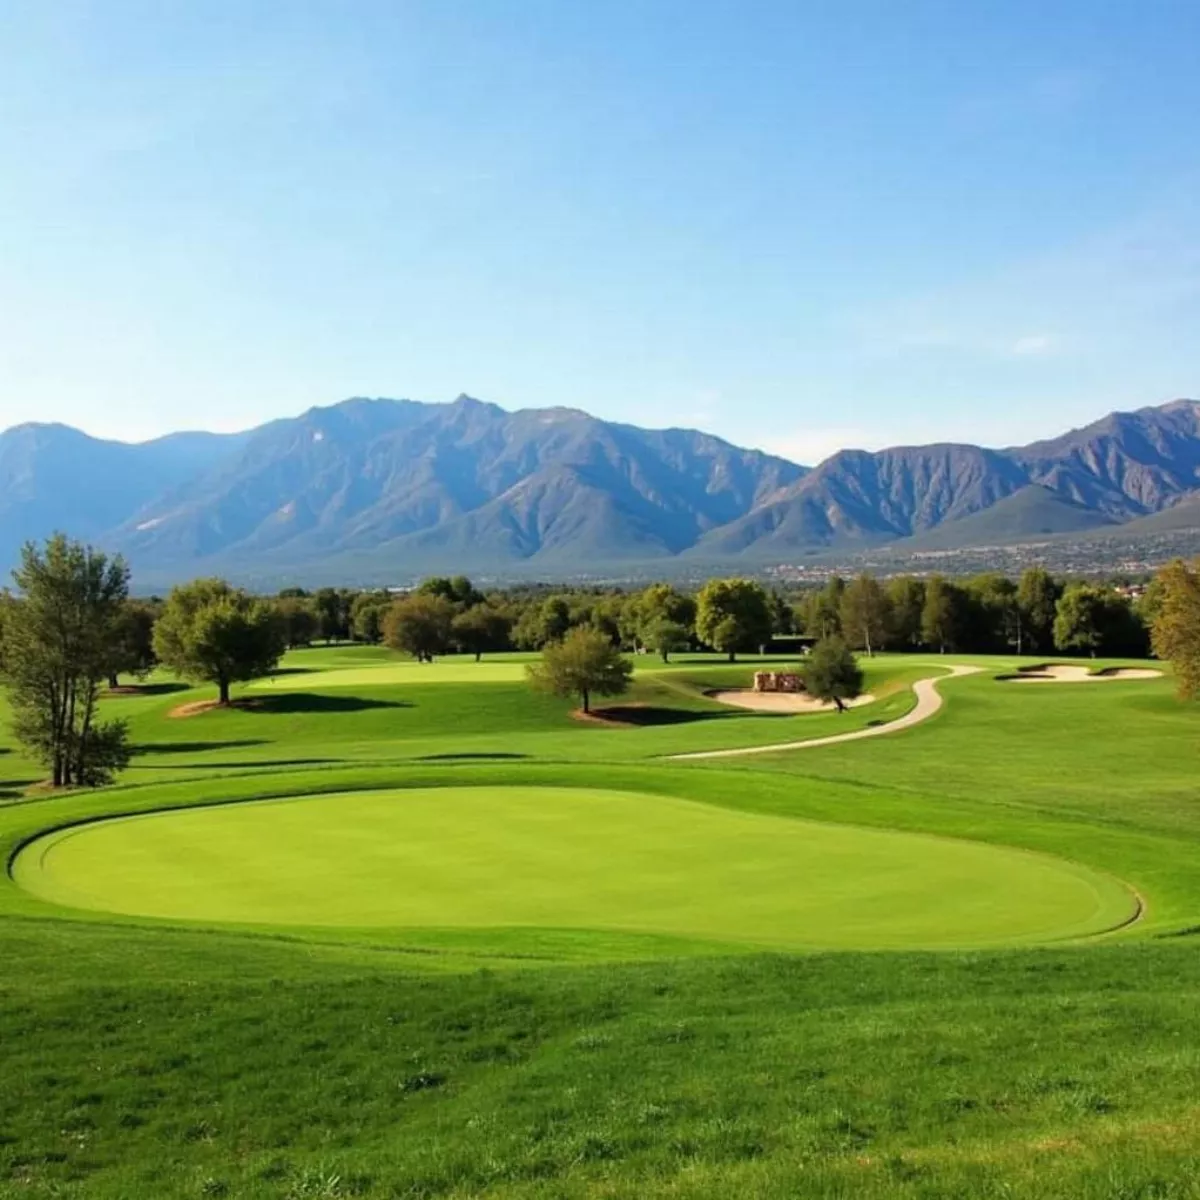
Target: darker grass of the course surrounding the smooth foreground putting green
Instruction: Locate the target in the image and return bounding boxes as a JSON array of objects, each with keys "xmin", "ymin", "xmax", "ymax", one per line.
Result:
[{"xmin": 0, "ymin": 647, "xmax": 1200, "ymax": 1200}]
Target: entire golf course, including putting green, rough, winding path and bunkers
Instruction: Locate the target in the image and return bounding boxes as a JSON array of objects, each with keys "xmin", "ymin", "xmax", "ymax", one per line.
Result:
[{"xmin": 0, "ymin": 644, "xmax": 1200, "ymax": 1200}]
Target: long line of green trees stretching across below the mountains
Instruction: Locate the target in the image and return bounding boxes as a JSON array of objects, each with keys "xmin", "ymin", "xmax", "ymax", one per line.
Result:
[{"xmin": 0, "ymin": 535, "xmax": 1200, "ymax": 786}]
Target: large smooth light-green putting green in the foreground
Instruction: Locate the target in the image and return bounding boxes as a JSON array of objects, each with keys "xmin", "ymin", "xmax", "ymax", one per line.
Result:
[{"xmin": 13, "ymin": 786, "xmax": 1135, "ymax": 948}]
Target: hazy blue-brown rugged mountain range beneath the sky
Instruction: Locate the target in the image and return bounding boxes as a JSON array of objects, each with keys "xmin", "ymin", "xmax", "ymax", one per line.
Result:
[{"xmin": 0, "ymin": 396, "xmax": 1200, "ymax": 583}]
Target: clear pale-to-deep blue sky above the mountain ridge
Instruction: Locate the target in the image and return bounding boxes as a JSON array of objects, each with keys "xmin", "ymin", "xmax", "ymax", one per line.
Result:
[{"xmin": 0, "ymin": 0, "xmax": 1200, "ymax": 461}]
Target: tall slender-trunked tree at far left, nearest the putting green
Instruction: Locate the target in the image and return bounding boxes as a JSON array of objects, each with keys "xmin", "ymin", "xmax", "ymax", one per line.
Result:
[{"xmin": 0, "ymin": 534, "xmax": 130, "ymax": 787}]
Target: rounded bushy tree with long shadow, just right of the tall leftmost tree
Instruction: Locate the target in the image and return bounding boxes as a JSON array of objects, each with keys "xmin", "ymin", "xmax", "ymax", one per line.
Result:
[{"xmin": 154, "ymin": 580, "xmax": 284, "ymax": 704}]
